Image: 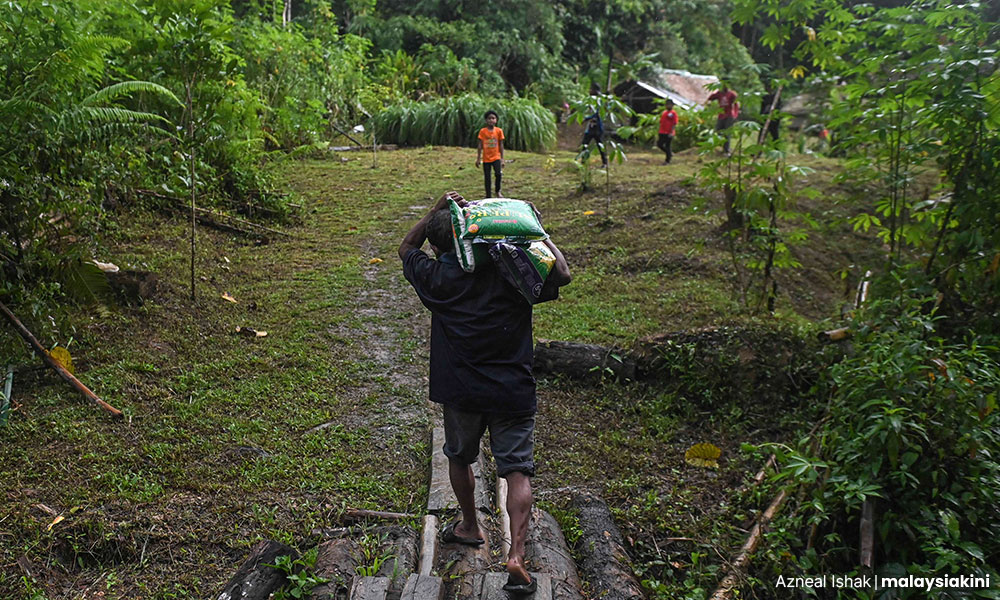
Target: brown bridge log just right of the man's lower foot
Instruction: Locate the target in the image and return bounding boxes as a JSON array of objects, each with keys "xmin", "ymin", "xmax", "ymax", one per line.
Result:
[{"xmin": 525, "ymin": 508, "xmax": 583, "ymax": 600}]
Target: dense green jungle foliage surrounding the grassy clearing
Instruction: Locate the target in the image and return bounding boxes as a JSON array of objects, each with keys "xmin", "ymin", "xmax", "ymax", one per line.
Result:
[{"xmin": 0, "ymin": 0, "xmax": 1000, "ymax": 597}]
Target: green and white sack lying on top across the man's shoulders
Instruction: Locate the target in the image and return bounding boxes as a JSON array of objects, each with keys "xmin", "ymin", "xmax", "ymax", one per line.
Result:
[{"xmin": 450, "ymin": 198, "xmax": 548, "ymax": 272}]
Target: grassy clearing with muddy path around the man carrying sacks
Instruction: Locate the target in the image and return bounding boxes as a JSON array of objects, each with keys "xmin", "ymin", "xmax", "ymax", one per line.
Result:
[{"xmin": 0, "ymin": 142, "xmax": 892, "ymax": 598}]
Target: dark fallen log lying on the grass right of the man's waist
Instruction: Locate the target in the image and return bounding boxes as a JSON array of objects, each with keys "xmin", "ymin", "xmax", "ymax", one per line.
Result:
[{"xmin": 535, "ymin": 339, "xmax": 636, "ymax": 381}]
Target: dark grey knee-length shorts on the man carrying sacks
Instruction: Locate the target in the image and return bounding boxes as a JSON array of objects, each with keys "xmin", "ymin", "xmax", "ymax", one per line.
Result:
[{"xmin": 444, "ymin": 404, "xmax": 535, "ymax": 477}]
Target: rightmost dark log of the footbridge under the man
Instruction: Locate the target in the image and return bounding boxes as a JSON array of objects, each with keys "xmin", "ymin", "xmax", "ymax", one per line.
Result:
[{"xmin": 573, "ymin": 493, "xmax": 645, "ymax": 600}]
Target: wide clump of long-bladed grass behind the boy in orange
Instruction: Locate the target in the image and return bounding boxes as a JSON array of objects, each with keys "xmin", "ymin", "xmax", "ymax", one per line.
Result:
[{"xmin": 372, "ymin": 94, "xmax": 556, "ymax": 152}]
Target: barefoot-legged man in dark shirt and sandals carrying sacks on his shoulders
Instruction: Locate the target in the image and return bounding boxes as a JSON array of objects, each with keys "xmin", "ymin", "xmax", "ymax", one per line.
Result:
[{"xmin": 399, "ymin": 192, "xmax": 571, "ymax": 594}]
